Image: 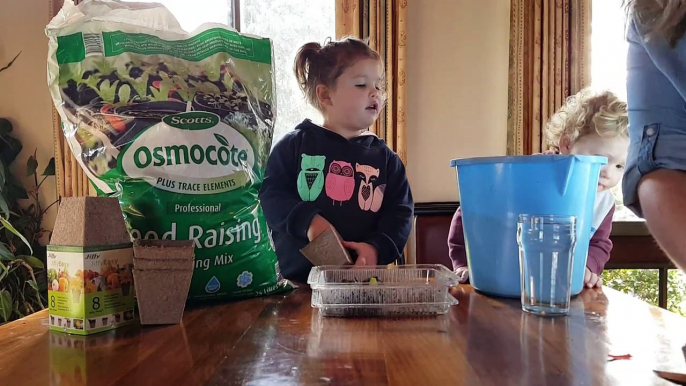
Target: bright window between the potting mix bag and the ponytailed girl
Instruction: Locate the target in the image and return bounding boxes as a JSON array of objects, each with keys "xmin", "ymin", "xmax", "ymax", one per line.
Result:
[{"xmin": 126, "ymin": 0, "xmax": 336, "ymax": 143}]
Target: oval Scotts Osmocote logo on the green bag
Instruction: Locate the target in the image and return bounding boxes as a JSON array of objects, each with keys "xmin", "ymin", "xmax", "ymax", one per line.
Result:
[{"xmin": 120, "ymin": 112, "xmax": 255, "ymax": 194}]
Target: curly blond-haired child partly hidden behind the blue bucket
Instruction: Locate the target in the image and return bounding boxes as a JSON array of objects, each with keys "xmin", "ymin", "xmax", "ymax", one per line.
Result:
[{"xmin": 448, "ymin": 89, "xmax": 629, "ymax": 288}]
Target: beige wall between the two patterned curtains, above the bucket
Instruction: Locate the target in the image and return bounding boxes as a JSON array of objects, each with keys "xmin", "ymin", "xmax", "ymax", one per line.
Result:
[{"xmin": 406, "ymin": 0, "xmax": 510, "ymax": 202}]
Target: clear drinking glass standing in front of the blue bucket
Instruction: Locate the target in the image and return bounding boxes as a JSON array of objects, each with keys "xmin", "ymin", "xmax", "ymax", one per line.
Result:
[{"xmin": 517, "ymin": 214, "xmax": 576, "ymax": 316}]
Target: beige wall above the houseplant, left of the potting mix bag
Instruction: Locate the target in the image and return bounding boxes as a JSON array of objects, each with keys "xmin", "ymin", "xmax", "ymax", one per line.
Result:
[{"xmin": 0, "ymin": 0, "xmax": 57, "ymax": 238}]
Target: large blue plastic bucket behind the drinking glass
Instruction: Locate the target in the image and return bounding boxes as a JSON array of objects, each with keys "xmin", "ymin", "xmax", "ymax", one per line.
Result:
[{"xmin": 450, "ymin": 155, "xmax": 607, "ymax": 297}]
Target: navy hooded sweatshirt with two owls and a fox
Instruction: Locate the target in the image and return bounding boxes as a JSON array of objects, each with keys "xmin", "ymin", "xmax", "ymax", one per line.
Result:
[{"xmin": 260, "ymin": 120, "xmax": 414, "ymax": 283}]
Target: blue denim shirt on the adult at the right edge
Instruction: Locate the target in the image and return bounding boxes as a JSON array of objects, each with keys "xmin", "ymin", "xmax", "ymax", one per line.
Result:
[{"xmin": 622, "ymin": 23, "xmax": 686, "ymax": 216}]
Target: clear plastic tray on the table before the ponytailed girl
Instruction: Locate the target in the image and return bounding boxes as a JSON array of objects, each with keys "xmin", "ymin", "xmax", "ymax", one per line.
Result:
[{"xmin": 307, "ymin": 264, "xmax": 458, "ymax": 316}]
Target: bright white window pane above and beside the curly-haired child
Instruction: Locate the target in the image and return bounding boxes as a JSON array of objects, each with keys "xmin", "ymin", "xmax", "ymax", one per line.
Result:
[{"xmin": 591, "ymin": 0, "xmax": 643, "ymax": 221}]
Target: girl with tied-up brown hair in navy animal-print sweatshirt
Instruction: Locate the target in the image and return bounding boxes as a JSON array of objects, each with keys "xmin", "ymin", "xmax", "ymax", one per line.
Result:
[{"xmin": 260, "ymin": 38, "xmax": 414, "ymax": 283}]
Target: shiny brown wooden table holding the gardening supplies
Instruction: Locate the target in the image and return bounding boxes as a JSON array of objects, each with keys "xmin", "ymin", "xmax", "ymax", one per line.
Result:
[{"xmin": 0, "ymin": 286, "xmax": 686, "ymax": 386}]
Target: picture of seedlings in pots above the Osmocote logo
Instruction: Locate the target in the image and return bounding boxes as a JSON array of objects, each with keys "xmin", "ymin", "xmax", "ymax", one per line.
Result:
[{"xmin": 60, "ymin": 54, "xmax": 274, "ymax": 176}]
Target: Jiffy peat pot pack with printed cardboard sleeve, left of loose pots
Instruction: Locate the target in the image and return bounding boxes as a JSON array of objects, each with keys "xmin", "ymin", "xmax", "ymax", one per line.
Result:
[{"xmin": 48, "ymin": 197, "xmax": 135, "ymax": 335}]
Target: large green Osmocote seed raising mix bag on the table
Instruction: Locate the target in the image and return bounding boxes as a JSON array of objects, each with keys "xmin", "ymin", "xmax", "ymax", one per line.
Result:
[{"xmin": 46, "ymin": 0, "xmax": 292, "ymax": 299}]
